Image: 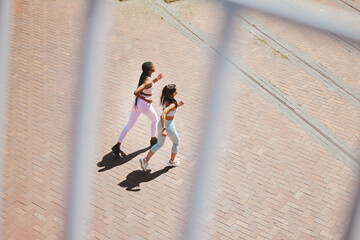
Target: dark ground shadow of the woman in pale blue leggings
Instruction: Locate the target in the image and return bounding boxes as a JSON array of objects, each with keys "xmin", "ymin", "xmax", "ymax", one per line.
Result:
[{"xmin": 118, "ymin": 166, "xmax": 173, "ymax": 192}]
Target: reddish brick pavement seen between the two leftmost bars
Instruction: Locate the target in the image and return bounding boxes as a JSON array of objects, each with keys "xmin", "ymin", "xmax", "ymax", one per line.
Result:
[{"xmin": 2, "ymin": 1, "xmax": 84, "ymax": 239}]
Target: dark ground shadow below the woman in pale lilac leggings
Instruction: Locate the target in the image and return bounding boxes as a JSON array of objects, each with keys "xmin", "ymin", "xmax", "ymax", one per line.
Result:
[{"xmin": 97, "ymin": 147, "xmax": 151, "ymax": 172}]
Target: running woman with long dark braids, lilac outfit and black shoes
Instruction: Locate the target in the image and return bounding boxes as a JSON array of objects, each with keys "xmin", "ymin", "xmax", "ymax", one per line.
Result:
[{"xmin": 111, "ymin": 62, "xmax": 163, "ymax": 156}]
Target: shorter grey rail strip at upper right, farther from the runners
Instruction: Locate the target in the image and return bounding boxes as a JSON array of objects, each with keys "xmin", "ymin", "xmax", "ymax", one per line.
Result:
[{"xmin": 241, "ymin": 16, "xmax": 360, "ymax": 108}]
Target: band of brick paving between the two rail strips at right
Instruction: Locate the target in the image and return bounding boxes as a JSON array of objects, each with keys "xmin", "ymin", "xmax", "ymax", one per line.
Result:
[{"xmin": 234, "ymin": 15, "xmax": 360, "ymax": 151}]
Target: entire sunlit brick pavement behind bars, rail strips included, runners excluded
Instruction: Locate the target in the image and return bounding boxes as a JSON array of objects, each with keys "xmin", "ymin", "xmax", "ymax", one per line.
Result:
[{"xmin": 2, "ymin": 0, "xmax": 360, "ymax": 240}]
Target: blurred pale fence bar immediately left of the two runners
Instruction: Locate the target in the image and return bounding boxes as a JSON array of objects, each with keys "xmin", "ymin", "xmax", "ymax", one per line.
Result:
[{"xmin": 65, "ymin": 0, "xmax": 110, "ymax": 240}]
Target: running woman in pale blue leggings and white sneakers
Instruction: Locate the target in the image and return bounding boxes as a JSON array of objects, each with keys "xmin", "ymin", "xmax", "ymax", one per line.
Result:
[{"xmin": 140, "ymin": 84, "xmax": 184, "ymax": 171}]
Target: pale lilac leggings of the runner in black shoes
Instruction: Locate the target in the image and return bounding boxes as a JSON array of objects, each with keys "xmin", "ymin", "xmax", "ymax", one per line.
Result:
[{"xmin": 118, "ymin": 98, "xmax": 158, "ymax": 143}]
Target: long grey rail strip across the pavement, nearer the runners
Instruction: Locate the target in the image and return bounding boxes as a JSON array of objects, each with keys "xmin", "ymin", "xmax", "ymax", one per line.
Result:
[{"xmin": 144, "ymin": 0, "xmax": 360, "ymax": 173}]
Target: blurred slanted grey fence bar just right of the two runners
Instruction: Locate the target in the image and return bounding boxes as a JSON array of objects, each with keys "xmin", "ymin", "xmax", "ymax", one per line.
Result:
[{"xmin": 185, "ymin": 3, "xmax": 237, "ymax": 240}]
